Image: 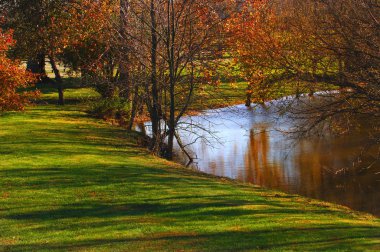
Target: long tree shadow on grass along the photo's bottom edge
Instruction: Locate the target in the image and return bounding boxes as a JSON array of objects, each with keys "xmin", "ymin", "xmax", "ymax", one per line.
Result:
[{"xmin": 3, "ymin": 226, "xmax": 380, "ymax": 251}]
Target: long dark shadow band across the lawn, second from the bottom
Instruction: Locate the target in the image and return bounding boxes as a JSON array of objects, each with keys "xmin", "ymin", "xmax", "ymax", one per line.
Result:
[{"xmin": 5, "ymin": 200, "xmax": 340, "ymax": 222}]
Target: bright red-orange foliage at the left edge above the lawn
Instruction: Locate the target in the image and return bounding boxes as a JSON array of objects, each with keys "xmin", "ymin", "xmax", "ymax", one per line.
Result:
[{"xmin": 0, "ymin": 29, "xmax": 38, "ymax": 112}]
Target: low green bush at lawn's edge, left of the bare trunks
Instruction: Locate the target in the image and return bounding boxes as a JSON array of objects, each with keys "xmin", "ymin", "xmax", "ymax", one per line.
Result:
[{"xmin": 89, "ymin": 97, "xmax": 131, "ymax": 125}]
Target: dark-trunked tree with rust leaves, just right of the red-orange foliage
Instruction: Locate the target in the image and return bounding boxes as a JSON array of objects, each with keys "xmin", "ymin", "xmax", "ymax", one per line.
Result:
[{"xmin": 3, "ymin": 0, "xmax": 108, "ymax": 105}]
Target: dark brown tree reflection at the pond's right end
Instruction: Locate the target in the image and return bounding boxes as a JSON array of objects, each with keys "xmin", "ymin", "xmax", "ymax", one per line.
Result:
[{"xmin": 294, "ymin": 137, "xmax": 380, "ymax": 214}]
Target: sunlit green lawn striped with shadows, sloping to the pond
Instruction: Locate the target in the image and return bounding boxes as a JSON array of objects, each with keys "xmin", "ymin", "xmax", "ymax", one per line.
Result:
[{"xmin": 0, "ymin": 105, "xmax": 380, "ymax": 251}]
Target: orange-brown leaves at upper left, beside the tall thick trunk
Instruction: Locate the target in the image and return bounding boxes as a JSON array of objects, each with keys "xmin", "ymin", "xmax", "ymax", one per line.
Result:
[{"xmin": 50, "ymin": 0, "xmax": 119, "ymax": 70}]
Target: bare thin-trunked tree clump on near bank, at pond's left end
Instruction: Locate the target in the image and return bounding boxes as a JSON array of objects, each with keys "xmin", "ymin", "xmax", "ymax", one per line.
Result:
[{"xmin": 119, "ymin": 0, "xmax": 232, "ymax": 159}]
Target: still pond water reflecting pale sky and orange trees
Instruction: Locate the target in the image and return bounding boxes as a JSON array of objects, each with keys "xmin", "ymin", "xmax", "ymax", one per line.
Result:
[{"xmin": 171, "ymin": 99, "xmax": 380, "ymax": 216}]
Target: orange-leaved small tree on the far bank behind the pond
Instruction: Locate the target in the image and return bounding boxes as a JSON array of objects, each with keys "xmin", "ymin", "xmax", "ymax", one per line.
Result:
[{"xmin": 226, "ymin": 0, "xmax": 283, "ymax": 101}]
